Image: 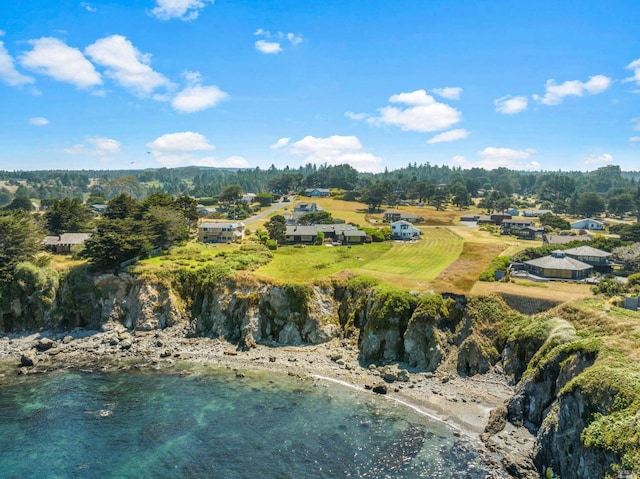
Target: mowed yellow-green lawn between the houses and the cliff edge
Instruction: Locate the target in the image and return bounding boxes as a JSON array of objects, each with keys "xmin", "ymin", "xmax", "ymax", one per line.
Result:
[{"xmin": 256, "ymin": 228, "xmax": 463, "ymax": 289}]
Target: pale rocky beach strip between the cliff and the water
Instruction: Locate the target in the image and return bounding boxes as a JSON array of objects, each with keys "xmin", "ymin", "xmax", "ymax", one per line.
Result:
[{"xmin": 0, "ymin": 322, "xmax": 540, "ymax": 478}]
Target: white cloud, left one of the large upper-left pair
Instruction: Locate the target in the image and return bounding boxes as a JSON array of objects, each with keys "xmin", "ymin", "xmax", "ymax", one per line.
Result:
[{"xmin": 19, "ymin": 37, "xmax": 102, "ymax": 88}]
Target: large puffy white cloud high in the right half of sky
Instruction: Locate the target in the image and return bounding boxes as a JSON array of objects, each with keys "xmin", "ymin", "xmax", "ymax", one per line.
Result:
[{"xmin": 362, "ymin": 90, "xmax": 462, "ymax": 132}]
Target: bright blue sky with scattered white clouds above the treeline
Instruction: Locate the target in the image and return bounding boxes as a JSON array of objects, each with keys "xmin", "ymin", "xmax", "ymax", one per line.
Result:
[{"xmin": 0, "ymin": 0, "xmax": 640, "ymax": 171}]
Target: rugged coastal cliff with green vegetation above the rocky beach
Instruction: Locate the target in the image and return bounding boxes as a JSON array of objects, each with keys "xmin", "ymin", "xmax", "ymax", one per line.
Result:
[{"xmin": 2, "ymin": 269, "xmax": 637, "ymax": 478}]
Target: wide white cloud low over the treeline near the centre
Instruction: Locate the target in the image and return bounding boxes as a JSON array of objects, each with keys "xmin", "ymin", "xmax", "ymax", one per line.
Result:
[{"xmin": 272, "ymin": 135, "xmax": 383, "ymax": 172}]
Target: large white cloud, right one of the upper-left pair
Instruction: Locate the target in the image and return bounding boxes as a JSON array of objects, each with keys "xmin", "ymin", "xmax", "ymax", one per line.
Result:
[{"xmin": 85, "ymin": 35, "xmax": 170, "ymax": 96}]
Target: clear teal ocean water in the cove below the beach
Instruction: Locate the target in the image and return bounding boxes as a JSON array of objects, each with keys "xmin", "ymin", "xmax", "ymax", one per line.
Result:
[{"xmin": 0, "ymin": 369, "xmax": 496, "ymax": 479}]
